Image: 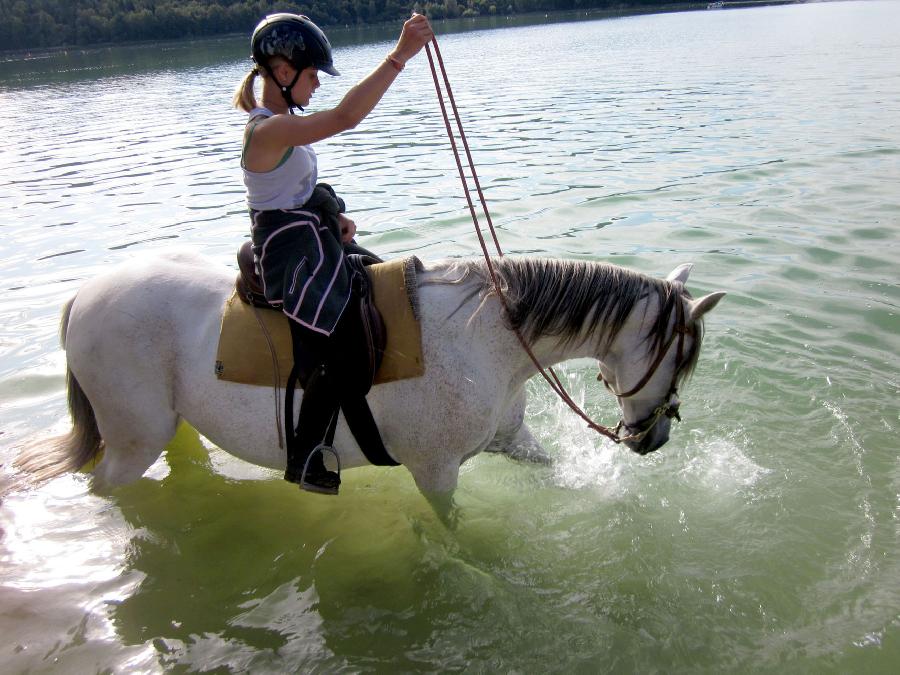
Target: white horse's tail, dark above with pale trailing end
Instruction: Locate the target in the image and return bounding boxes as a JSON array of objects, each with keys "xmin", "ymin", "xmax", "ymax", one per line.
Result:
[{"xmin": 15, "ymin": 298, "xmax": 103, "ymax": 483}]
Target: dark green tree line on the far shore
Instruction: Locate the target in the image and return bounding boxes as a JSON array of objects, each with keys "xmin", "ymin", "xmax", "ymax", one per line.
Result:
[{"xmin": 0, "ymin": 0, "xmax": 690, "ymax": 50}]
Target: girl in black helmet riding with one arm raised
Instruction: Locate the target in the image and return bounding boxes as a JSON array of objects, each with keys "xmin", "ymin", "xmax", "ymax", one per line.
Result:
[{"xmin": 234, "ymin": 14, "xmax": 433, "ymax": 494}]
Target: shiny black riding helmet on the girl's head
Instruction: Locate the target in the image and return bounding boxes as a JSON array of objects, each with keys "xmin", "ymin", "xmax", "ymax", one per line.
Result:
[{"xmin": 250, "ymin": 13, "xmax": 340, "ymax": 75}]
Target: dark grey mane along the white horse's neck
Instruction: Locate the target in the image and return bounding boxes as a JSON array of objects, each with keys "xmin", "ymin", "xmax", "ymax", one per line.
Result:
[{"xmin": 434, "ymin": 256, "xmax": 703, "ymax": 388}]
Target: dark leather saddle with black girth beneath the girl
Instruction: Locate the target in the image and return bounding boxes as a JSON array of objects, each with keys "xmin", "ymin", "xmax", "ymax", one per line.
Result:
[{"xmin": 235, "ymin": 241, "xmax": 398, "ymax": 466}]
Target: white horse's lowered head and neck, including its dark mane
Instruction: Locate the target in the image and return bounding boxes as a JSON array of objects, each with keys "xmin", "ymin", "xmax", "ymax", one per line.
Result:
[{"xmin": 461, "ymin": 257, "xmax": 725, "ymax": 455}]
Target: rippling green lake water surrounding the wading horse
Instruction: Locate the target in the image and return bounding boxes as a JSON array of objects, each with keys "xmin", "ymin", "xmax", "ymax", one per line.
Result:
[{"xmin": 0, "ymin": 2, "xmax": 900, "ymax": 673}]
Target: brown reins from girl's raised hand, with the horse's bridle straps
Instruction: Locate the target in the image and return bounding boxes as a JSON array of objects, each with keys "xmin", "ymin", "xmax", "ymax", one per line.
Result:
[{"xmin": 425, "ymin": 37, "xmax": 688, "ymax": 443}]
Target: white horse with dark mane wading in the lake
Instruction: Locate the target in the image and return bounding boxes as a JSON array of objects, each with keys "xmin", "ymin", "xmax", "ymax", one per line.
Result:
[{"xmin": 17, "ymin": 253, "xmax": 724, "ymax": 512}]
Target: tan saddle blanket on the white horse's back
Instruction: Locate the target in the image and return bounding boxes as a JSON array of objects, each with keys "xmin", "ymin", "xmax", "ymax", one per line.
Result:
[{"xmin": 216, "ymin": 256, "xmax": 425, "ymax": 387}]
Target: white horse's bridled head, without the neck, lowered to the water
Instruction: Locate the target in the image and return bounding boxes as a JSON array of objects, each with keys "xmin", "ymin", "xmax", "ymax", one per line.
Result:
[{"xmin": 598, "ymin": 264, "xmax": 725, "ymax": 455}]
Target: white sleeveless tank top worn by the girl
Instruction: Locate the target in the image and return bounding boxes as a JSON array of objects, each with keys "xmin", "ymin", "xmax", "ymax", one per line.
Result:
[{"xmin": 241, "ymin": 108, "xmax": 318, "ymax": 211}]
